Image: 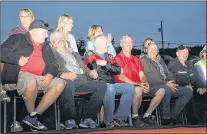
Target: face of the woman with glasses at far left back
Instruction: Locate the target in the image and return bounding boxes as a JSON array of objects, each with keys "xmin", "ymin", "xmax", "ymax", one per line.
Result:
[{"xmin": 19, "ymin": 11, "xmax": 33, "ymax": 29}]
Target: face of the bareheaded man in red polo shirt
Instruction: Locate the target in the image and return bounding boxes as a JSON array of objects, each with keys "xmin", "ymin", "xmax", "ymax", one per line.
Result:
[{"xmin": 122, "ymin": 37, "xmax": 133, "ymax": 53}]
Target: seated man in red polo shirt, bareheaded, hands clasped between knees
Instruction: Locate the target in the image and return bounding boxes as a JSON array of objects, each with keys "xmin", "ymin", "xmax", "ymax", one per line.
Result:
[{"xmin": 115, "ymin": 35, "xmax": 164, "ymax": 127}]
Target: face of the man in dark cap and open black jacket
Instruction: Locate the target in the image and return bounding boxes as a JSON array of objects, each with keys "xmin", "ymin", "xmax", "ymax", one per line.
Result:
[{"xmin": 32, "ymin": 28, "xmax": 48, "ymax": 43}]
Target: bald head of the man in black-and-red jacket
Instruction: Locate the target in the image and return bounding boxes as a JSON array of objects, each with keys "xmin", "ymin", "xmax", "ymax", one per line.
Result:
[{"xmin": 93, "ymin": 35, "xmax": 108, "ymax": 54}]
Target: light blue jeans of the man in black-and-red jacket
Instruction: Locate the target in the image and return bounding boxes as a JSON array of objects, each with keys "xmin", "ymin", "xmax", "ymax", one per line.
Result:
[{"xmin": 103, "ymin": 83, "xmax": 134, "ymax": 123}]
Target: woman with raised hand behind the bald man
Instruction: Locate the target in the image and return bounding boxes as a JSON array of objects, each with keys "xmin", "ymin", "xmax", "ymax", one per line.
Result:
[{"xmin": 86, "ymin": 25, "xmax": 116, "ymax": 57}]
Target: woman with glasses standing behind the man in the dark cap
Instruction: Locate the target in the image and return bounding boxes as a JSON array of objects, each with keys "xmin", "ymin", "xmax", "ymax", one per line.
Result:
[{"xmin": 9, "ymin": 8, "xmax": 35, "ymax": 36}]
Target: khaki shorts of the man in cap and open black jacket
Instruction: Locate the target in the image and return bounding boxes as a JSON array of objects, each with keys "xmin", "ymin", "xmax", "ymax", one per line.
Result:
[{"xmin": 5, "ymin": 72, "xmax": 63, "ymax": 95}]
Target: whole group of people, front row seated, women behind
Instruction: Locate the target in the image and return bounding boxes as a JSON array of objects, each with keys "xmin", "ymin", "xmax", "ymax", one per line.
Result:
[{"xmin": 1, "ymin": 9, "xmax": 206, "ymax": 130}]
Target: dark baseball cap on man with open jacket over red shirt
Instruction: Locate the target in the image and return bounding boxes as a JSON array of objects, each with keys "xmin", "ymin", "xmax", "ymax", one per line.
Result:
[{"xmin": 29, "ymin": 20, "xmax": 53, "ymax": 31}]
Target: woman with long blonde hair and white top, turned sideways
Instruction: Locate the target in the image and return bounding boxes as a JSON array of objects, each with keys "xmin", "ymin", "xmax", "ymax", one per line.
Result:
[{"xmin": 56, "ymin": 14, "xmax": 78, "ymax": 52}]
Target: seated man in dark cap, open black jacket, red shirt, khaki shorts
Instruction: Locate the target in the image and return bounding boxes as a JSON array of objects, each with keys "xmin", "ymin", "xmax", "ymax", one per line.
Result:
[{"xmin": 1, "ymin": 20, "xmax": 65, "ymax": 130}]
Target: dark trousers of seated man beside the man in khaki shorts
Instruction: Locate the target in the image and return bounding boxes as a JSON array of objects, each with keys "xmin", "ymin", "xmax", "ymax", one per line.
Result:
[{"xmin": 60, "ymin": 80, "xmax": 107, "ymax": 122}]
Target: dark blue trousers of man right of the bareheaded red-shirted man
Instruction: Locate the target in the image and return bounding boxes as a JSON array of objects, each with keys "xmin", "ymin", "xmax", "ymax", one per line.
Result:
[{"xmin": 161, "ymin": 86, "xmax": 193, "ymax": 119}]
